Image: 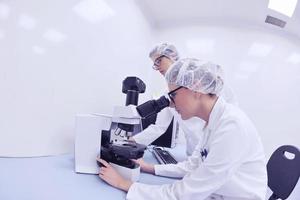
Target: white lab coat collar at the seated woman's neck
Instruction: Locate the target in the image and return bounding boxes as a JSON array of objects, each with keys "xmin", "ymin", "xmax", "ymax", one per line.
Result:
[{"xmin": 205, "ymin": 97, "xmax": 226, "ymax": 130}]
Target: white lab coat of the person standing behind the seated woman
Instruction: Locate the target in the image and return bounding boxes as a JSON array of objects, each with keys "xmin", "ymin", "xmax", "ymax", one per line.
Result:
[{"xmin": 133, "ymin": 83, "xmax": 237, "ymax": 156}]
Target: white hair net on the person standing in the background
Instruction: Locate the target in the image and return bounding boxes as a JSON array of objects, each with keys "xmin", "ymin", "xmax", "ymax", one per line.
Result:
[{"xmin": 149, "ymin": 43, "xmax": 179, "ymax": 62}]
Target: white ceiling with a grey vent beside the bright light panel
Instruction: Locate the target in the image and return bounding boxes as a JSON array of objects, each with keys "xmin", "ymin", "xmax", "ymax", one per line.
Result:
[{"xmin": 136, "ymin": 0, "xmax": 300, "ymax": 39}]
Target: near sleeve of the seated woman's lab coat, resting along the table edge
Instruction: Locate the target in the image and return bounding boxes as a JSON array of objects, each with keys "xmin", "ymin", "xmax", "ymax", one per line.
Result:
[{"xmin": 127, "ymin": 119, "xmax": 247, "ymax": 200}]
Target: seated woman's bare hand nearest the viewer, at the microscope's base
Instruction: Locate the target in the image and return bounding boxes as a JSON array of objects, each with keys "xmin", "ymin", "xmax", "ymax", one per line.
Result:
[{"xmin": 96, "ymin": 157, "xmax": 132, "ymax": 192}]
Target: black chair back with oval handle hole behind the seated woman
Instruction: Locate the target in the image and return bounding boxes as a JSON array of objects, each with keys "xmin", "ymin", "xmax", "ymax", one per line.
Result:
[{"xmin": 267, "ymin": 145, "xmax": 300, "ymax": 200}]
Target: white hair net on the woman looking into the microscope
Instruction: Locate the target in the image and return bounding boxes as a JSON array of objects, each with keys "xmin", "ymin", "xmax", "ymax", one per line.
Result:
[{"xmin": 165, "ymin": 58, "xmax": 224, "ymax": 96}]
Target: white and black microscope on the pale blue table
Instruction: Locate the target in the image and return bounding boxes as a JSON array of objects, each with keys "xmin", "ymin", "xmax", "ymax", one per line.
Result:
[{"xmin": 75, "ymin": 77, "xmax": 170, "ymax": 181}]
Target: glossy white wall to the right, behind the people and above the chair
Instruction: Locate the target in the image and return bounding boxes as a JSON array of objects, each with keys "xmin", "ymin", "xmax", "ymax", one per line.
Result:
[{"xmin": 157, "ymin": 22, "xmax": 300, "ymax": 157}]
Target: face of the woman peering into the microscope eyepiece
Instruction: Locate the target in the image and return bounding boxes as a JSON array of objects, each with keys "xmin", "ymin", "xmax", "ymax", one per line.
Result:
[{"xmin": 169, "ymin": 85, "xmax": 197, "ymax": 120}]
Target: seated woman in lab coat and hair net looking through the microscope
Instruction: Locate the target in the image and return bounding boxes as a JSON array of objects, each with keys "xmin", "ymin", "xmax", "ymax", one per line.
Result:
[{"xmin": 99, "ymin": 59, "xmax": 267, "ymax": 200}]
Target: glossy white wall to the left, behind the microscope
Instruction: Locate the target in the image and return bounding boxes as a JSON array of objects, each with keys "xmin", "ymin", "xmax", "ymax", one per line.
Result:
[{"xmin": 0, "ymin": 0, "xmax": 158, "ymax": 156}]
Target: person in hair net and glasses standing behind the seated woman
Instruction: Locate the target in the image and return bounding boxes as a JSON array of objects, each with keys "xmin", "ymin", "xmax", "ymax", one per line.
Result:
[{"xmin": 132, "ymin": 43, "xmax": 237, "ymax": 155}]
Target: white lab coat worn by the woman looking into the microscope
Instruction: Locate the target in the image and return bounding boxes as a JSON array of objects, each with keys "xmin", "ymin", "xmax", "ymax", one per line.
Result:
[{"xmin": 127, "ymin": 97, "xmax": 267, "ymax": 200}]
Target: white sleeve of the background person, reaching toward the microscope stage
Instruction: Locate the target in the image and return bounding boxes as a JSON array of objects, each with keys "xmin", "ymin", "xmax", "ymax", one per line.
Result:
[{"xmin": 133, "ymin": 108, "xmax": 173, "ymax": 145}]
